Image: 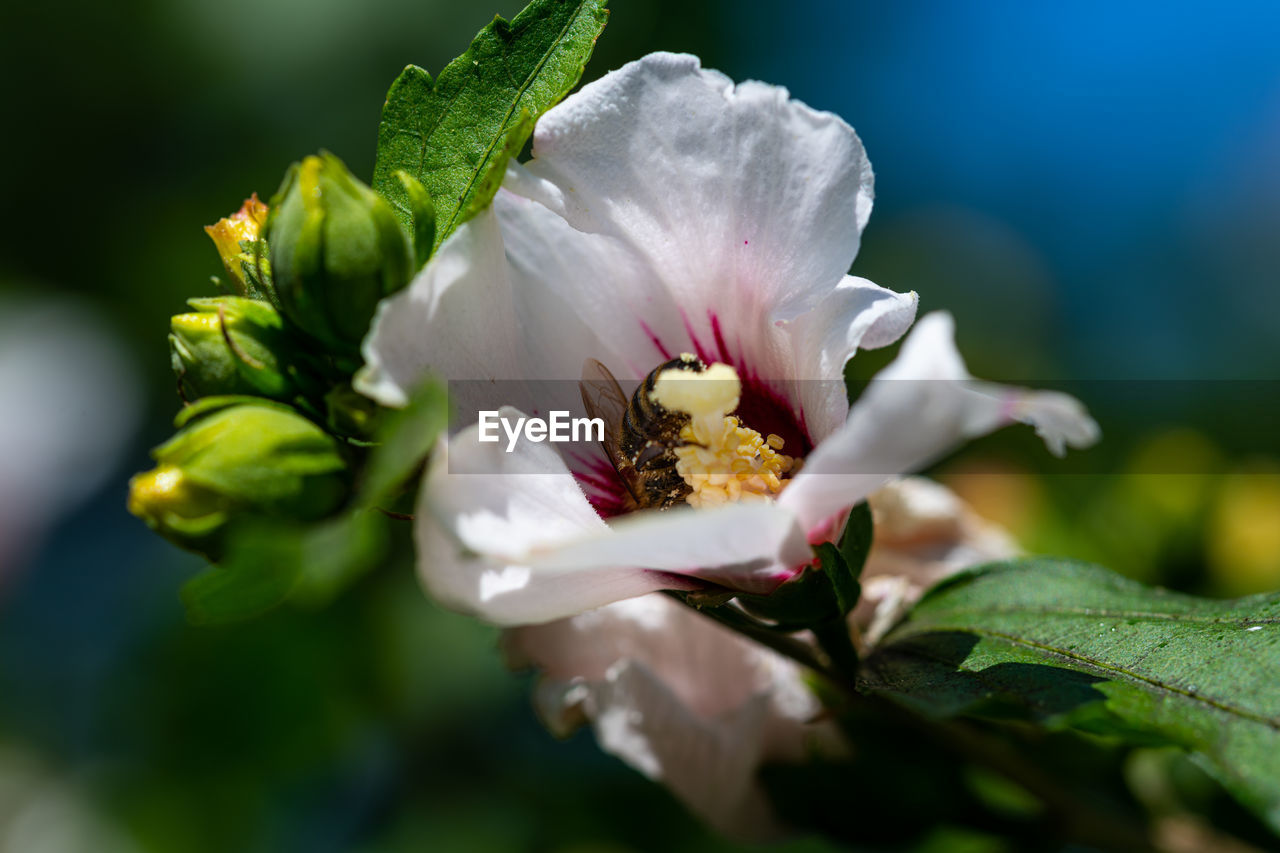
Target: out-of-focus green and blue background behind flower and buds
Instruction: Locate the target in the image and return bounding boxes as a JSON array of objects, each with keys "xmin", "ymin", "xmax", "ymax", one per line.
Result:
[{"xmin": 0, "ymin": 0, "xmax": 1280, "ymax": 853}]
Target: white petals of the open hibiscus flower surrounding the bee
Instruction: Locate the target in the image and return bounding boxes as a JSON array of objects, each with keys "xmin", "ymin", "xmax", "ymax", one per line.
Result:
[{"xmin": 360, "ymin": 54, "xmax": 1097, "ymax": 625}]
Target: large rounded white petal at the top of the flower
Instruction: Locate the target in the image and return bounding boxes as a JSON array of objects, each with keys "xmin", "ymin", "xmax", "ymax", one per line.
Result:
[{"xmin": 507, "ymin": 54, "xmax": 872, "ymax": 356}]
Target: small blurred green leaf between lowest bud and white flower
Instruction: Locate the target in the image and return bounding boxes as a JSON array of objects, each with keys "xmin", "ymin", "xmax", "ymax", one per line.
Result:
[{"xmin": 360, "ymin": 380, "xmax": 449, "ymax": 506}]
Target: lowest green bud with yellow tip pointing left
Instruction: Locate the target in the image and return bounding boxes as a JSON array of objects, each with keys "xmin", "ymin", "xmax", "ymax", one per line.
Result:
[{"xmin": 128, "ymin": 397, "xmax": 351, "ymax": 560}]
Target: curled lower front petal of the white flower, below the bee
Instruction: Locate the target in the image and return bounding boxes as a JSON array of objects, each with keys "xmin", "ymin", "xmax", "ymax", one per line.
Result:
[{"xmin": 416, "ymin": 409, "xmax": 812, "ymax": 624}]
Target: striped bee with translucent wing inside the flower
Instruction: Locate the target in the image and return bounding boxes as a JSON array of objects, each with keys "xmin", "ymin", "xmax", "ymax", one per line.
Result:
[{"xmin": 579, "ymin": 355, "xmax": 707, "ymax": 510}]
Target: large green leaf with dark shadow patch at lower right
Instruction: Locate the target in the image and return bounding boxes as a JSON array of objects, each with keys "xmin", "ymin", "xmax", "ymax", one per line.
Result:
[{"xmin": 861, "ymin": 558, "xmax": 1280, "ymax": 830}]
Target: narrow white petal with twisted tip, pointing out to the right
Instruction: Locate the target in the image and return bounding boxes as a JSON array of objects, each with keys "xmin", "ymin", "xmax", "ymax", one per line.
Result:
[{"xmin": 778, "ymin": 313, "xmax": 1098, "ymax": 529}]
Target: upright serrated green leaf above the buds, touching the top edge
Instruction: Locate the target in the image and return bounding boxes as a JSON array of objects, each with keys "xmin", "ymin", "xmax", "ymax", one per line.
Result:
[{"xmin": 372, "ymin": 0, "xmax": 608, "ymax": 248}]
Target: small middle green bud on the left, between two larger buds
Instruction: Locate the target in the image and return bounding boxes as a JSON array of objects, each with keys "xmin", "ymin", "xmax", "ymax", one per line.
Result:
[{"xmin": 169, "ymin": 296, "xmax": 297, "ymax": 400}]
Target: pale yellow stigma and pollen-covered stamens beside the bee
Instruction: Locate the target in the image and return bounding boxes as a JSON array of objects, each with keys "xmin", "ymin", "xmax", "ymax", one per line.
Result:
[{"xmin": 652, "ymin": 364, "xmax": 800, "ymax": 506}]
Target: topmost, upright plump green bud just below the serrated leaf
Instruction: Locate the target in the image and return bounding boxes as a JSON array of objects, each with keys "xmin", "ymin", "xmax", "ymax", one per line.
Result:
[{"xmin": 268, "ymin": 154, "xmax": 411, "ymax": 352}]
